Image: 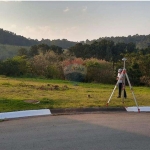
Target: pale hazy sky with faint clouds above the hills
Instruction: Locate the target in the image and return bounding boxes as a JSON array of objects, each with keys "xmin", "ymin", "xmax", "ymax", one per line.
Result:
[{"xmin": 0, "ymin": 1, "xmax": 150, "ymax": 42}]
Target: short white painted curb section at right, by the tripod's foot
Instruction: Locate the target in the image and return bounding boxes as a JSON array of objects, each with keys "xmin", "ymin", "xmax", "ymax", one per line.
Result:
[{"xmin": 125, "ymin": 106, "xmax": 150, "ymax": 112}]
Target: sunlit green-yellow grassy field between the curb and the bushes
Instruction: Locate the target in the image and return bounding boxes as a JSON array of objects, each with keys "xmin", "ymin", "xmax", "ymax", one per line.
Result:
[{"xmin": 0, "ymin": 76, "xmax": 150, "ymax": 112}]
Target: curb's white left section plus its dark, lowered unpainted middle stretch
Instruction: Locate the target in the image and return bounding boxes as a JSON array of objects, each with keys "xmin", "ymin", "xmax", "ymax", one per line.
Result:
[{"xmin": 0, "ymin": 107, "xmax": 126, "ymax": 120}]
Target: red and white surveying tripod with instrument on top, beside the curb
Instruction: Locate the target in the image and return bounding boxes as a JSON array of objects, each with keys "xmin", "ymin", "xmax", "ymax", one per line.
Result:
[{"xmin": 106, "ymin": 58, "xmax": 140, "ymax": 112}]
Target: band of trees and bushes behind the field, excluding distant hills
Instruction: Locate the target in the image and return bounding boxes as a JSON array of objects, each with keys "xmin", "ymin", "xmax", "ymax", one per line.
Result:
[{"xmin": 0, "ymin": 39, "xmax": 150, "ymax": 86}]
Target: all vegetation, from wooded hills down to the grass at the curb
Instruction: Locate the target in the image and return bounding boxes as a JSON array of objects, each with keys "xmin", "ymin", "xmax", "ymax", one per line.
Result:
[{"xmin": 0, "ymin": 29, "xmax": 150, "ymax": 112}]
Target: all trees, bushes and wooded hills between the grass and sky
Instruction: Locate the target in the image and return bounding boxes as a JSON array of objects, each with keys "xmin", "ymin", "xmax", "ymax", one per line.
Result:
[{"xmin": 0, "ymin": 29, "xmax": 150, "ymax": 86}]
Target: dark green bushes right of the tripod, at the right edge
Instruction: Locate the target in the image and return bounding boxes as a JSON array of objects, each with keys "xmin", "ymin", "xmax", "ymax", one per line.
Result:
[{"xmin": 117, "ymin": 52, "xmax": 150, "ymax": 86}]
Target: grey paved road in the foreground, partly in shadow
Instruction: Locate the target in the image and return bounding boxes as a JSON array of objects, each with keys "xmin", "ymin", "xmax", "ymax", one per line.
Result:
[{"xmin": 0, "ymin": 112, "xmax": 150, "ymax": 150}]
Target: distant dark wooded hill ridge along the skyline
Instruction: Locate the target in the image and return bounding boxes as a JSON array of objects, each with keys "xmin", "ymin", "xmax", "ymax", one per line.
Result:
[{"xmin": 0, "ymin": 29, "xmax": 150, "ymax": 49}]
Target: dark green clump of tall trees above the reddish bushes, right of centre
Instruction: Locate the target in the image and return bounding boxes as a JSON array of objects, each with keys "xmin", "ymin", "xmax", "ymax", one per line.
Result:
[{"xmin": 69, "ymin": 39, "xmax": 136, "ymax": 69}]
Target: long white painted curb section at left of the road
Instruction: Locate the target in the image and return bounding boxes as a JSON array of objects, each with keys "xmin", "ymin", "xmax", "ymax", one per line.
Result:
[{"xmin": 0, "ymin": 109, "xmax": 51, "ymax": 119}]
